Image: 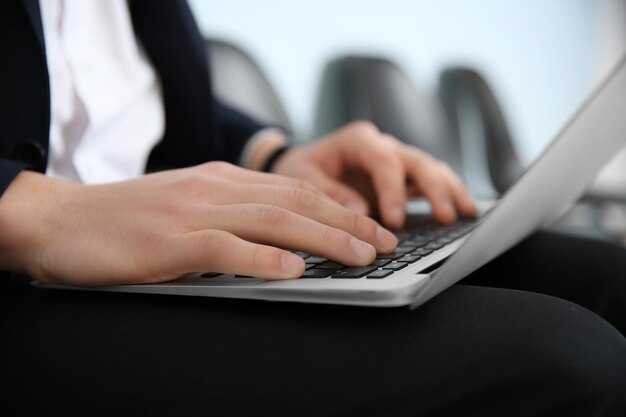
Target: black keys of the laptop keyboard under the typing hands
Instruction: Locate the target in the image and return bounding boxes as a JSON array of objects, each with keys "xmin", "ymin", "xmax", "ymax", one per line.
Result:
[{"xmin": 202, "ymin": 215, "xmax": 478, "ymax": 279}]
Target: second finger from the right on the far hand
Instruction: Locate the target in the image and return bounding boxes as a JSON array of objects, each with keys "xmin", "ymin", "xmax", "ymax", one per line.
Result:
[{"xmin": 402, "ymin": 148, "xmax": 456, "ymax": 224}]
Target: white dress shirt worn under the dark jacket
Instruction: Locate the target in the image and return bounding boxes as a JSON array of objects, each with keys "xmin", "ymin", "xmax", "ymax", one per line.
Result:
[{"xmin": 39, "ymin": 0, "xmax": 165, "ymax": 184}]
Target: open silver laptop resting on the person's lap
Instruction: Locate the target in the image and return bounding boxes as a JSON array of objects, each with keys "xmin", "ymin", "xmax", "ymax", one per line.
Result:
[{"xmin": 37, "ymin": 55, "xmax": 626, "ymax": 308}]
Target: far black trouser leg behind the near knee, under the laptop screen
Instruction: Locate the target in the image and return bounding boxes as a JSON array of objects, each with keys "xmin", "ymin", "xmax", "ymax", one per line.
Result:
[{"xmin": 462, "ymin": 228, "xmax": 626, "ymax": 334}]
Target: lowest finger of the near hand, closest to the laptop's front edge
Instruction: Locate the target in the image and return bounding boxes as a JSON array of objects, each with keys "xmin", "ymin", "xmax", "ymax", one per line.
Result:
[{"xmin": 168, "ymin": 230, "xmax": 305, "ymax": 279}]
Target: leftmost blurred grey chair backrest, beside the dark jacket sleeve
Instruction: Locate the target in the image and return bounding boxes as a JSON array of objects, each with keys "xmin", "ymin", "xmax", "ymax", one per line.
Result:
[{"xmin": 206, "ymin": 39, "xmax": 292, "ymax": 132}]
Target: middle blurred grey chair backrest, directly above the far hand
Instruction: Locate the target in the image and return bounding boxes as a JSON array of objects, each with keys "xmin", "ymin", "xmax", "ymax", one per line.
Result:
[{"xmin": 315, "ymin": 56, "xmax": 461, "ymax": 171}]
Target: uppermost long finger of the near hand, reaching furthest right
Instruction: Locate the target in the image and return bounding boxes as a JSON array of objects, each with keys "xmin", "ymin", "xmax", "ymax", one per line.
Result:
[{"xmin": 206, "ymin": 184, "xmax": 398, "ymax": 253}]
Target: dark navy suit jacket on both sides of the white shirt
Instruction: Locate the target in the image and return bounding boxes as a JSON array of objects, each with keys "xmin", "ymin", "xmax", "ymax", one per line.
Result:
[{"xmin": 0, "ymin": 0, "xmax": 263, "ymax": 196}]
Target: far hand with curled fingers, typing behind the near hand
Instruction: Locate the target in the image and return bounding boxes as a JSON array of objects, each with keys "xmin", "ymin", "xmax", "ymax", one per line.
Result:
[{"xmin": 273, "ymin": 122, "xmax": 476, "ymax": 228}]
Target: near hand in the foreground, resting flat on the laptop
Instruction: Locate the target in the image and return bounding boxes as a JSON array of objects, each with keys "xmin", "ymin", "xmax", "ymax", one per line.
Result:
[{"xmin": 0, "ymin": 162, "xmax": 397, "ymax": 285}]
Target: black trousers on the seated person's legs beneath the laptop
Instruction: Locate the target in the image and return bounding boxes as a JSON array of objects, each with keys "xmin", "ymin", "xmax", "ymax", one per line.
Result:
[{"xmin": 0, "ymin": 232, "xmax": 626, "ymax": 417}]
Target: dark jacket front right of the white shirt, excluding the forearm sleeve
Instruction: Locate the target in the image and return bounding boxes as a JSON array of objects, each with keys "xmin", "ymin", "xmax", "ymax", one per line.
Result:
[{"xmin": 128, "ymin": 0, "xmax": 224, "ymax": 171}]
